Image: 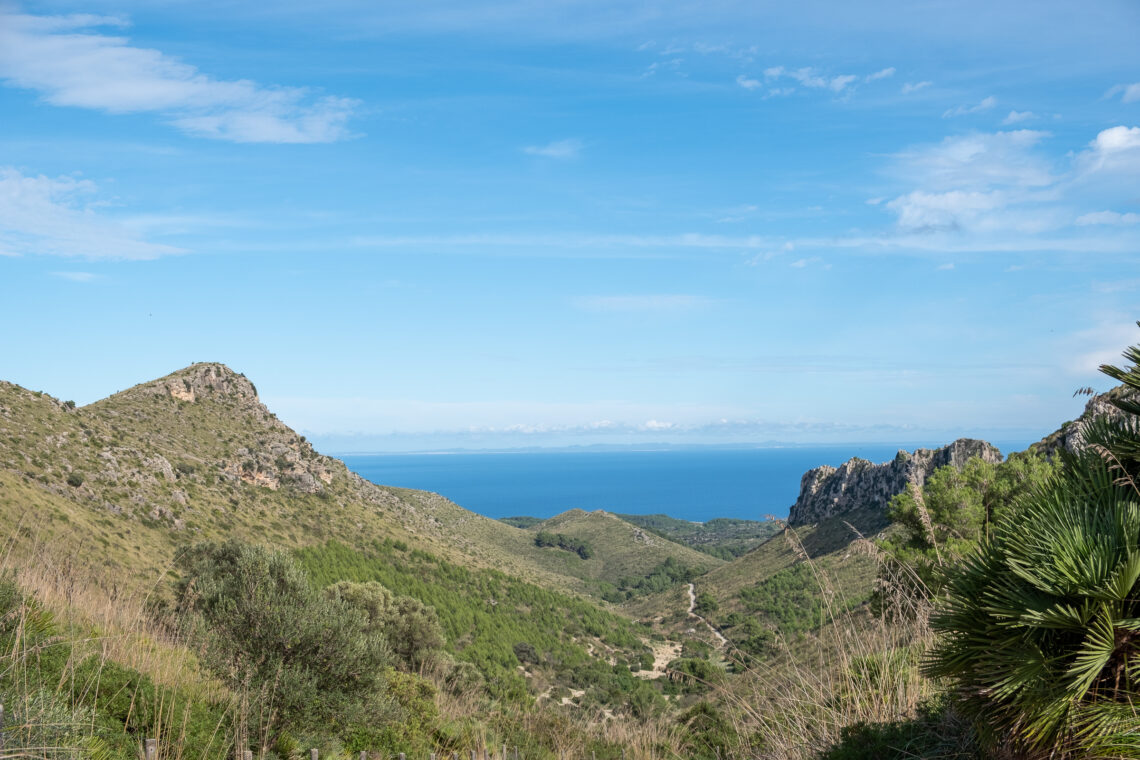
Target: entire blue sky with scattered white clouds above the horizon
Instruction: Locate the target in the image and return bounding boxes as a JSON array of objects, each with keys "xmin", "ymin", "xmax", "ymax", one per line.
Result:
[{"xmin": 0, "ymin": 0, "xmax": 1140, "ymax": 450}]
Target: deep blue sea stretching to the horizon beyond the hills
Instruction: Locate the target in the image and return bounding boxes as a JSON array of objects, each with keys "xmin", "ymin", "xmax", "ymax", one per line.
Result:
[{"xmin": 340, "ymin": 443, "xmax": 1025, "ymax": 522}]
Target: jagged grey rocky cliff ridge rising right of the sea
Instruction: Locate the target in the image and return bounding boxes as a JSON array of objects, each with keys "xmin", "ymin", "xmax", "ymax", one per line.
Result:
[{"xmin": 788, "ymin": 438, "xmax": 1002, "ymax": 525}]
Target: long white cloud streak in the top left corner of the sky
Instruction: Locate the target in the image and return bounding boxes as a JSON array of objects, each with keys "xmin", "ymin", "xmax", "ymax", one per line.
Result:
[{"xmin": 0, "ymin": 10, "xmax": 358, "ymax": 142}]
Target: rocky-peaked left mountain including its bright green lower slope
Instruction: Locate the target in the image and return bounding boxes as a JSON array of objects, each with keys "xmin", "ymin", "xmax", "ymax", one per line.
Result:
[{"xmin": 0, "ymin": 363, "xmax": 674, "ymax": 706}]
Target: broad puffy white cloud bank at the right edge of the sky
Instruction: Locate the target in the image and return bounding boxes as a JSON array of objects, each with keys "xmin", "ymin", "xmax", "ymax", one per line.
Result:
[{"xmin": 839, "ymin": 126, "xmax": 1140, "ymax": 254}]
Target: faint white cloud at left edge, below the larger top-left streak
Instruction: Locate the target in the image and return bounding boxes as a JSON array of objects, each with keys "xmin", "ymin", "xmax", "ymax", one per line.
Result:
[{"xmin": 0, "ymin": 167, "xmax": 185, "ymax": 259}]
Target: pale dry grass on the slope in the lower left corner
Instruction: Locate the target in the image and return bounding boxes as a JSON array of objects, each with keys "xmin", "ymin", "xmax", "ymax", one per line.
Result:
[{"xmin": 0, "ymin": 525, "xmax": 230, "ymax": 760}]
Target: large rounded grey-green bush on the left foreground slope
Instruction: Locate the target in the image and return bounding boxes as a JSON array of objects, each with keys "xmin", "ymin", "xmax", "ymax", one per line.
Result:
[{"xmin": 176, "ymin": 541, "xmax": 389, "ymax": 744}]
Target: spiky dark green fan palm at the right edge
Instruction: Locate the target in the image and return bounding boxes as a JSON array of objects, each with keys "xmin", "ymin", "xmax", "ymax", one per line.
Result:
[{"xmin": 928, "ymin": 348, "xmax": 1140, "ymax": 758}]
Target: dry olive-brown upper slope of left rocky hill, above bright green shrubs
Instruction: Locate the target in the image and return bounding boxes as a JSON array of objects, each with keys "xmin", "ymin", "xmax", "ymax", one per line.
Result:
[{"xmin": 0, "ymin": 363, "xmax": 714, "ymax": 593}]
